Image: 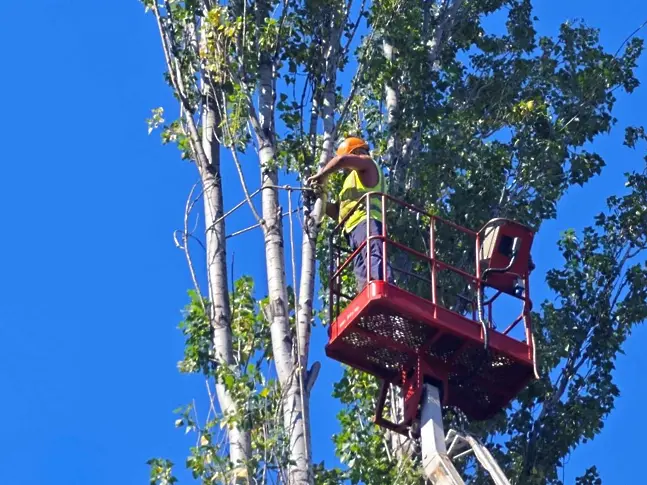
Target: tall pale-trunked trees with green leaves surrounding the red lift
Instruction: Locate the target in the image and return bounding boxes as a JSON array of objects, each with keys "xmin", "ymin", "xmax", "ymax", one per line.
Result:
[{"xmin": 143, "ymin": 0, "xmax": 647, "ymax": 485}]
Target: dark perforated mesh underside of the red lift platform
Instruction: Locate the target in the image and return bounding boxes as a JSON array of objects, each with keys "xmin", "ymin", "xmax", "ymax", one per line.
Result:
[{"xmin": 327, "ymin": 306, "xmax": 533, "ymax": 419}]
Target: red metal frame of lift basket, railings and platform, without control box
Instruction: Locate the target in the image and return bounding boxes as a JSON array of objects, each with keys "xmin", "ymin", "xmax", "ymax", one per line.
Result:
[{"xmin": 326, "ymin": 192, "xmax": 534, "ymax": 426}]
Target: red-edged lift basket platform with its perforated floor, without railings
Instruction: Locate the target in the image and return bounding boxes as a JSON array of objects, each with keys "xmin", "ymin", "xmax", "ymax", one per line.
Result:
[{"xmin": 326, "ymin": 281, "xmax": 534, "ymax": 420}]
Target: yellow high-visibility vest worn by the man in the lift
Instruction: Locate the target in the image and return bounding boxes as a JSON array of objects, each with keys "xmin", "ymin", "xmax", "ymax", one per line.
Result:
[{"xmin": 339, "ymin": 160, "xmax": 385, "ymax": 232}]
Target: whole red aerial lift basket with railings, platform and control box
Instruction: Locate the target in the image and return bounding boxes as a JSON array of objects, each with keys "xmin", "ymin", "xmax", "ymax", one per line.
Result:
[{"xmin": 326, "ymin": 192, "xmax": 536, "ymax": 432}]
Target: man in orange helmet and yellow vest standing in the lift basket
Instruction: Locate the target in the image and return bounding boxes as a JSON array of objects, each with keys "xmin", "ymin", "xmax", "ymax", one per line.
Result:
[{"xmin": 307, "ymin": 137, "xmax": 391, "ymax": 292}]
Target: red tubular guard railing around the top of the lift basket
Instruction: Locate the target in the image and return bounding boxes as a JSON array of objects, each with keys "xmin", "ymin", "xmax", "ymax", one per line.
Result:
[{"xmin": 328, "ymin": 192, "xmax": 533, "ymax": 352}]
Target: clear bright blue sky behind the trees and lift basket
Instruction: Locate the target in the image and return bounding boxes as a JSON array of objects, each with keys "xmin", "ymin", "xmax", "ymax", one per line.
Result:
[{"xmin": 0, "ymin": 0, "xmax": 647, "ymax": 485}]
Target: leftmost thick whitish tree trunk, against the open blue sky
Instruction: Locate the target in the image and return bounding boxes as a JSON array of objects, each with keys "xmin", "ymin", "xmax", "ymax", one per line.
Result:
[{"xmin": 200, "ymin": 92, "xmax": 251, "ymax": 474}]
